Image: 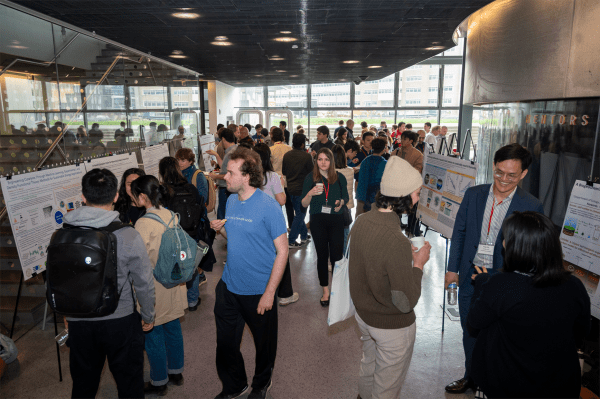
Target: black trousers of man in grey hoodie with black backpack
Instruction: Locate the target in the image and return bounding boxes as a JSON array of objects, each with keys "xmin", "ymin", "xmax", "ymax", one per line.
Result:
[{"xmin": 68, "ymin": 312, "xmax": 144, "ymax": 398}]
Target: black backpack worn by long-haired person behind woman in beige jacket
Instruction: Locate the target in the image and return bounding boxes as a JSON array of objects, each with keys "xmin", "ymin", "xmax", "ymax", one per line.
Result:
[{"xmin": 167, "ymin": 184, "xmax": 204, "ymax": 237}]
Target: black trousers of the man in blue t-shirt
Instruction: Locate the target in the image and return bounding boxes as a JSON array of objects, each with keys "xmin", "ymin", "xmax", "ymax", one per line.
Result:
[{"xmin": 215, "ymin": 280, "xmax": 277, "ymax": 394}]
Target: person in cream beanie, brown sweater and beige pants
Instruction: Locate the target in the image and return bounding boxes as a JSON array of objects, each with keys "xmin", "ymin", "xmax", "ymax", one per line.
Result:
[{"xmin": 348, "ymin": 157, "xmax": 431, "ymax": 398}]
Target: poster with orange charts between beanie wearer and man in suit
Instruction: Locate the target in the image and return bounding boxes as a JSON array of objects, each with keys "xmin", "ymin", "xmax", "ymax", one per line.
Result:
[{"xmin": 417, "ymin": 151, "xmax": 478, "ymax": 238}]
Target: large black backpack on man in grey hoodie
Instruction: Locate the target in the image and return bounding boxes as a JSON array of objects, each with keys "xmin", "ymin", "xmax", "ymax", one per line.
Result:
[{"xmin": 46, "ymin": 222, "xmax": 130, "ymax": 318}]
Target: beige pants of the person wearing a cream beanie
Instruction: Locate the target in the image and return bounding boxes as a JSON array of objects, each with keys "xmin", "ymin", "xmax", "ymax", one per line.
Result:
[{"xmin": 355, "ymin": 313, "xmax": 417, "ymax": 399}]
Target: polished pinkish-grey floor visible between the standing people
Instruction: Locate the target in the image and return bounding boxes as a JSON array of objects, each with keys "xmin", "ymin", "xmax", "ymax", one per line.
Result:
[{"xmin": 0, "ymin": 216, "xmax": 472, "ymax": 399}]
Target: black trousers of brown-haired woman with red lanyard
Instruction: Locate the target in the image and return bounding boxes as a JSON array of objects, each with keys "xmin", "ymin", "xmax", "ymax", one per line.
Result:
[{"xmin": 310, "ymin": 213, "xmax": 344, "ymax": 287}]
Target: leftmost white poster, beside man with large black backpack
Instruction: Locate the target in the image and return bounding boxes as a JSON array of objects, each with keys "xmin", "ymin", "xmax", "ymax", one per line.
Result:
[{"xmin": 0, "ymin": 164, "xmax": 85, "ymax": 280}]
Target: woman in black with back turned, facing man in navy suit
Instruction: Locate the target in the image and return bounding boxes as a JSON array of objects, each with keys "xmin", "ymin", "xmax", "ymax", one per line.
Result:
[{"xmin": 467, "ymin": 212, "xmax": 590, "ymax": 398}]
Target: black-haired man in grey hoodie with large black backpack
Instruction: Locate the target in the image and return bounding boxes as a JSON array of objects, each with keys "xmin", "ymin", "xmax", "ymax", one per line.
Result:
[{"xmin": 46, "ymin": 169, "xmax": 155, "ymax": 398}]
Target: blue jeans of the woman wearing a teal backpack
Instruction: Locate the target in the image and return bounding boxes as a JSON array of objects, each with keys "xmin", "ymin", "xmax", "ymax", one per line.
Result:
[{"xmin": 146, "ymin": 319, "xmax": 183, "ymax": 386}]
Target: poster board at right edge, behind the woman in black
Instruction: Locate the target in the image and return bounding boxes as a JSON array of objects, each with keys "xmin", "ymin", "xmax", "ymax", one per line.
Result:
[{"xmin": 560, "ymin": 180, "xmax": 600, "ymax": 318}]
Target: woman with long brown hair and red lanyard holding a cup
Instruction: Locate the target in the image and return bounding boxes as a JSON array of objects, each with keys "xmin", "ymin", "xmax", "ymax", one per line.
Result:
[{"xmin": 302, "ymin": 148, "xmax": 348, "ymax": 307}]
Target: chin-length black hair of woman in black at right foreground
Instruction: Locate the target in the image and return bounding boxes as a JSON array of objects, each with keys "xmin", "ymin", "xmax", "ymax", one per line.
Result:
[{"xmin": 502, "ymin": 211, "xmax": 569, "ymax": 287}]
